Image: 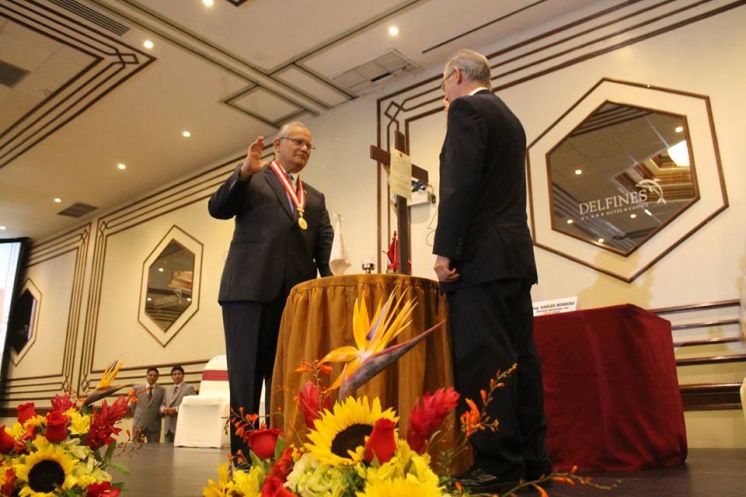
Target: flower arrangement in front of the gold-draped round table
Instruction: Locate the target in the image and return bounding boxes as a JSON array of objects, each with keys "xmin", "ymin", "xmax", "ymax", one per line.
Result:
[{"xmin": 202, "ymin": 295, "xmax": 605, "ymax": 497}]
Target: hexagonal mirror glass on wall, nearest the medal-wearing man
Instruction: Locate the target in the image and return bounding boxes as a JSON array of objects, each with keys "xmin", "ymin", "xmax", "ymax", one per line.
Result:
[{"xmin": 145, "ymin": 240, "xmax": 195, "ymax": 331}]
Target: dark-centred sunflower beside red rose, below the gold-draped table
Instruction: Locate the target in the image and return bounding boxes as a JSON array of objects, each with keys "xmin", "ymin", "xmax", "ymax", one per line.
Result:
[{"xmin": 305, "ymin": 396, "xmax": 398, "ymax": 466}]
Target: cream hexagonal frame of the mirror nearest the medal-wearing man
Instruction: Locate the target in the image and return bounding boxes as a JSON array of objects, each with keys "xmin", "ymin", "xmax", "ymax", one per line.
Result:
[{"xmin": 138, "ymin": 225, "xmax": 203, "ymax": 347}]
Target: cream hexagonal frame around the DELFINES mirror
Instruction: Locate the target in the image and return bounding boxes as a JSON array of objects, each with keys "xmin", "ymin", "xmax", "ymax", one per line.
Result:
[{"xmin": 526, "ymin": 78, "xmax": 728, "ymax": 283}]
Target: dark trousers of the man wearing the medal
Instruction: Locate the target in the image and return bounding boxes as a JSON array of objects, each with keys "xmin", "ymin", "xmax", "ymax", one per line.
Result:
[{"xmin": 221, "ymin": 295, "xmax": 286, "ymax": 459}]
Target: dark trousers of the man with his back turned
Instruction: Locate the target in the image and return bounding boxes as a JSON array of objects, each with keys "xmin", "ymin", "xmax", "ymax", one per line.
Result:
[{"xmin": 448, "ymin": 279, "xmax": 551, "ymax": 480}]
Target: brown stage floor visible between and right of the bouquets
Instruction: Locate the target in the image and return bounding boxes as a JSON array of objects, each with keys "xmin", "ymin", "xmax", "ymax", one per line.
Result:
[{"xmin": 119, "ymin": 444, "xmax": 746, "ymax": 497}]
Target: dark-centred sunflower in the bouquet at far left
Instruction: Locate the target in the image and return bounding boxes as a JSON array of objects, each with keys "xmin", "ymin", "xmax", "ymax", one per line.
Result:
[{"xmin": 13, "ymin": 436, "xmax": 77, "ymax": 497}]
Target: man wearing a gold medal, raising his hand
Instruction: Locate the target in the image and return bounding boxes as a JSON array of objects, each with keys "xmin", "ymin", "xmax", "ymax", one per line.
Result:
[{"xmin": 208, "ymin": 121, "xmax": 334, "ymax": 462}]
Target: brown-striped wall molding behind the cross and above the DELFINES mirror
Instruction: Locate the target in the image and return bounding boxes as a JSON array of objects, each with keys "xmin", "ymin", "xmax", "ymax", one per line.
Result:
[{"xmin": 376, "ymin": 0, "xmax": 746, "ymax": 270}]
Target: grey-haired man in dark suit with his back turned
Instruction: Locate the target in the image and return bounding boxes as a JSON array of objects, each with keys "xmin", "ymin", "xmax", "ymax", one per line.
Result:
[{"xmin": 433, "ymin": 50, "xmax": 551, "ymax": 492}]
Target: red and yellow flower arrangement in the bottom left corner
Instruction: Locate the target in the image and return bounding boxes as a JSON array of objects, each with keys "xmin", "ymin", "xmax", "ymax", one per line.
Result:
[{"xmin": 0, "ymin": 362, "xmax": 129, "ymax": 497}]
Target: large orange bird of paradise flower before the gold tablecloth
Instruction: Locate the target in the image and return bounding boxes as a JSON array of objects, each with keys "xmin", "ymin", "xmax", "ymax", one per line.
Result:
[{"xmin": 319, "ymin": 291, "xmax": 445, "ymax": 400}]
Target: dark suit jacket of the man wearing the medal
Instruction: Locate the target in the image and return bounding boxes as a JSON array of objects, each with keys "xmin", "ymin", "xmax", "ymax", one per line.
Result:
[{"xmin": 208, "ymin": 168, "xmax": 334, "ymax": 303}]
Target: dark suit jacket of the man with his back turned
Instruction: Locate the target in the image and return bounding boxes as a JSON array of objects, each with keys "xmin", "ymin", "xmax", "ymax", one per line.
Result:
[{"xmin": 433, "ymin": 90, "xmax": 537, "ymax": 292}]
